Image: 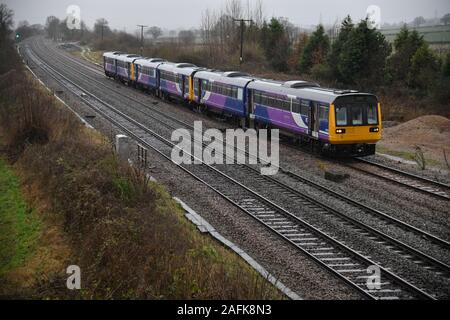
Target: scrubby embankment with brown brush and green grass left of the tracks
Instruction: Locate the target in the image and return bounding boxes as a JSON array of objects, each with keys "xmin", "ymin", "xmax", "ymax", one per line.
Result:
[{"xmin": 0, "ymin": 43, "xmax": 282, "ymax": 299}]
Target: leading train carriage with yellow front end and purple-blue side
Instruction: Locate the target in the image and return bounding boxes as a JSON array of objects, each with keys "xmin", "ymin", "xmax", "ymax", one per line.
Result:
[{"xmin": 247, "ymin": 80, "xmax": 381, "ymax": 156}]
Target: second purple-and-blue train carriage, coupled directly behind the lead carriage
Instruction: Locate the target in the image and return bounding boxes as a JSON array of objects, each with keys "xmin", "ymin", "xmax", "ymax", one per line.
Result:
[{"xmin": 193, "ymin": 71, "xmax": 253, "ymax": 120}]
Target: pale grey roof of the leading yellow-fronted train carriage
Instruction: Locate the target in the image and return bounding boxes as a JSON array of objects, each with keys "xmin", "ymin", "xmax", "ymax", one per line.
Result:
[{"xmin": 248, "ymin": 79, "xmax": 373, "ymax": 103}]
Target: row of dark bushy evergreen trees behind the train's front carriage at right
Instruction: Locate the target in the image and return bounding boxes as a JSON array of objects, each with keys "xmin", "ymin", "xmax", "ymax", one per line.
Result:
[{"xmin": 297, "ymin": 17, "xmax": 450, "ymax": 103}]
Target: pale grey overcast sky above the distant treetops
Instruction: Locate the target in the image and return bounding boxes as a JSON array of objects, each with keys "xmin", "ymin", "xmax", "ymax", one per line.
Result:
[{"xmin": 1, "ymin": 0, "xmax": 450, "ymax": 32}]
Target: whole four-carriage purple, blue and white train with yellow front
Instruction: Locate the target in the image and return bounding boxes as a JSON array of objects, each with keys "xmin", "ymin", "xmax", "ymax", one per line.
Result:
[{"xmin": 103, "ymin": 52, "xmax": 382, "ymax": 157}]
